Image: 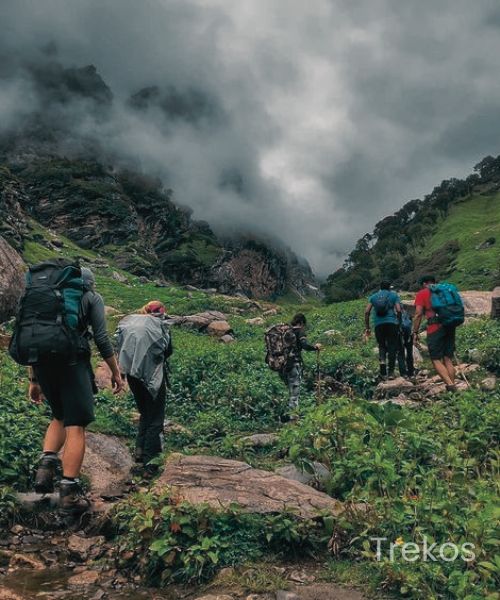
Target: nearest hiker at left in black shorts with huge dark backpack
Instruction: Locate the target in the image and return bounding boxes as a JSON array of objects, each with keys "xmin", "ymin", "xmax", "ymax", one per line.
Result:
[{"xmin": 9, "ymin": 259, "xmax": 123, "ymax": 516}]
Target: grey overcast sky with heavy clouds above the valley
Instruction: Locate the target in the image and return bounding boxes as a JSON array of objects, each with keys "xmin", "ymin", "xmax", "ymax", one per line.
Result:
[{"xmin": 0, "ymin": 0, "xmax": 500, "ymax": 274}]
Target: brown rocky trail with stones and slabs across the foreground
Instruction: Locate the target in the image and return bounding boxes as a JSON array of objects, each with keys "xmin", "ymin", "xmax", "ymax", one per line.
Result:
[{"xmin": 0, "ymin": 433, "xmax": 372, "ymax": 600}]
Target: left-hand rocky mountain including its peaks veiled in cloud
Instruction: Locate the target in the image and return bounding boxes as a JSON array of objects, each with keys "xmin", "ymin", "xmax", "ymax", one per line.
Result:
[{"xmin": 0, "ymin": 58, "xmax": 315, "ymax": 297}]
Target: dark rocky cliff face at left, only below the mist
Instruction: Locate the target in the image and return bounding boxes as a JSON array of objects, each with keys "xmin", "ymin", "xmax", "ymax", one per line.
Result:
[{"xmin": 0, "ymin": 157, "xmax": 314, "ymax": 298}]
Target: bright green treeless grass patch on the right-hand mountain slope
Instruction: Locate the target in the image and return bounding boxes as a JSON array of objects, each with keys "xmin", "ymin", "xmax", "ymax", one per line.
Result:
[{"xmin": 425, "ymin": 194, "xmax": 500, "ymax": 290}]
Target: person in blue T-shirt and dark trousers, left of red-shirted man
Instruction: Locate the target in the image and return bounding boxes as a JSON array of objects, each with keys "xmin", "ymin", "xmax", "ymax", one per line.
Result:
[{"xmin": 365, "ymin": 280, "xmax": 401, "ymax": 379}]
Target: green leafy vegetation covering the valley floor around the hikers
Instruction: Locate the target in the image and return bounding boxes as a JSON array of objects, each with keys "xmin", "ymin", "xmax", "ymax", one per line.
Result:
[{"xmin": 0, "ymin": 228, "xmax": 500, "ymax": 600}]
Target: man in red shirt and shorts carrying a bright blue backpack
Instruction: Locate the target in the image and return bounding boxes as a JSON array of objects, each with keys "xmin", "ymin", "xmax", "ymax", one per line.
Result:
[{"xmin": 413, "ymin": 275, "xmax": 465, "ymax": 392}]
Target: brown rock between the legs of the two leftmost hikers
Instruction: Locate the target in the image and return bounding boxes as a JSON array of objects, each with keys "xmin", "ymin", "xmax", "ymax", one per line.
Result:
[{"xmin": 82, "ymin": 433, "xmax": 134, "ymax": 498}]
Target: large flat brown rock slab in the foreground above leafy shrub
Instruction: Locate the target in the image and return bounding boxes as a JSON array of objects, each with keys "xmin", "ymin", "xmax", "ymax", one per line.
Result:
[{"xmin": 153, "ymin": 454, "xmax": 344, "ymax": 519}]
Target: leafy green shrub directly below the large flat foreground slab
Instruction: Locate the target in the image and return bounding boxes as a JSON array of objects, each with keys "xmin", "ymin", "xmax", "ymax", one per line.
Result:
[{"xmin": 112, "ymin": 494, "xmax": 325, "ymax": 585}]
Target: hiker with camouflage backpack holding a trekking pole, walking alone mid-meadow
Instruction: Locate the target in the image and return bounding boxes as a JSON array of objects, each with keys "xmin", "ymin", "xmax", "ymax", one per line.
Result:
[{"xmin": 265, "ymin": 313, "xmax": 322, "ymax": 418}]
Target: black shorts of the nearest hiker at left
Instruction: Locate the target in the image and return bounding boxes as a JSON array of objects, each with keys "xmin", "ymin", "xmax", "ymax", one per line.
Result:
[{"xmin": 34, "ymin": 359, "xmax": 95, "ymax": 427}]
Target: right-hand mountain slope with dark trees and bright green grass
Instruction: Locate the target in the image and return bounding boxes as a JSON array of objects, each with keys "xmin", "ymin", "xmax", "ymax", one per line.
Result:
[{"xmin": 324, "ymin": 156, "xmax": 500, "ymax": 302}]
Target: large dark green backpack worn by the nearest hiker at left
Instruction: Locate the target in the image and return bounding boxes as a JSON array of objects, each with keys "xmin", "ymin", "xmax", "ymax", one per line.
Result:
[{"xmin": 9, "ymin": 259, "xmax": 85, "ymax": 366}]
